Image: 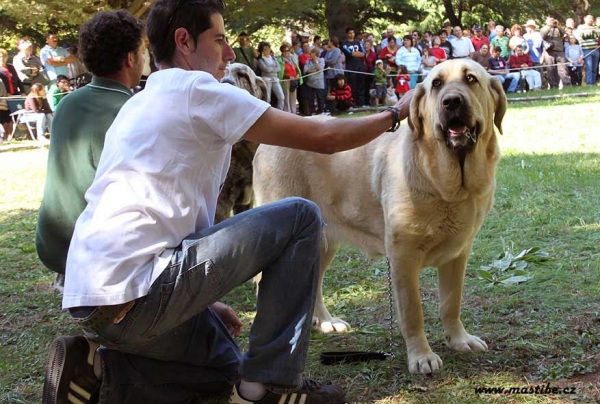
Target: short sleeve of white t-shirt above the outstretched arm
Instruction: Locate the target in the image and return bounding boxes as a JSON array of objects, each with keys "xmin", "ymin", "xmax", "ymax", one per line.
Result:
[{"xmin": 190, "ymin": 75, "xmax": 270, "ymax": 145}]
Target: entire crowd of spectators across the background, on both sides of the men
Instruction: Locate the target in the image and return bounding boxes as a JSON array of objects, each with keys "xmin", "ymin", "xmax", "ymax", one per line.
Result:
[{"xmin": 0, "ymin": 15, "xmax": 600, "ymax": 142}]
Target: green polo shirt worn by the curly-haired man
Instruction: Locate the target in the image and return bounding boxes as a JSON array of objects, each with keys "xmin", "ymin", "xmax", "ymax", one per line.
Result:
[{"xmin": 35, "ymin": 76, "xmax": 132, "ymax": 274}]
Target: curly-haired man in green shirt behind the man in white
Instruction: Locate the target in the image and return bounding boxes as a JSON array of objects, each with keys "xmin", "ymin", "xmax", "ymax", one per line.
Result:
[{"xmin": 35, "ymin": 11, "xmax": 144, "ymax": 288}]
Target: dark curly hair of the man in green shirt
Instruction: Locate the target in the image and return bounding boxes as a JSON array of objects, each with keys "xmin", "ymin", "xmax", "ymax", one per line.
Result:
[{"xmin": 79, "ymin": 10, "xmax": 144, "ymax": 76}]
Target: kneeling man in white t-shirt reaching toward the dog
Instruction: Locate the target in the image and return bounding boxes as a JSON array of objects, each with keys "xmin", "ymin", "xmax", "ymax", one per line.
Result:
[{"xmin": 44, "ymin": 0, "xmax": 411, "ymax": 404}]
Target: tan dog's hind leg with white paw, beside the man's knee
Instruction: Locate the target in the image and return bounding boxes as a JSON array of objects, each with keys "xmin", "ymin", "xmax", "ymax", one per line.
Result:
[{"xmin": 313, "ymin": 240, "xmax": 350, "ymax": 333}]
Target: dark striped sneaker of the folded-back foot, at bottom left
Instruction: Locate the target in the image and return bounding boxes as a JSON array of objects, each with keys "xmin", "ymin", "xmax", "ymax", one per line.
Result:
[{"xmin": 42, "ymin": 336, "xmax": 100, "ymax": 404}]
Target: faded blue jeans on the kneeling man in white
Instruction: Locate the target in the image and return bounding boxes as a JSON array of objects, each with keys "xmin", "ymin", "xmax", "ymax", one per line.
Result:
[{"xmin": 78, "ymin": 198, "xmax": 322, "ymax": 403}]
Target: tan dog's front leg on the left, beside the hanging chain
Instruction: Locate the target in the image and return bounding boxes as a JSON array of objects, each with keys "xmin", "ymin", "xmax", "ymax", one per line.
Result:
[{"xmin": 388, "ymin": 250, "xmax": 442, "ymax": 374}]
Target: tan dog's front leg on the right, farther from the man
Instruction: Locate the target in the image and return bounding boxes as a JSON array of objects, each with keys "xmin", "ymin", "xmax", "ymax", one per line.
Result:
[{"xmin": 438, "ymin": 254, "xmax": 488, "ymax": 352}]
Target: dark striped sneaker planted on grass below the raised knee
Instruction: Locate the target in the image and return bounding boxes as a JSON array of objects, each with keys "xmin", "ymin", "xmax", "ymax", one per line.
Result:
[{"xmin": 229, "ymin": 379, "xmax": 346, "ymax": 404}]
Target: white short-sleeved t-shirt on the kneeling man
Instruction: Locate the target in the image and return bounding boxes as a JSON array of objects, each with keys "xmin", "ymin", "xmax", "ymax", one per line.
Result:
[{"xmin": 63, "ymin": 68, "xmax": 269, "ymax": 308}]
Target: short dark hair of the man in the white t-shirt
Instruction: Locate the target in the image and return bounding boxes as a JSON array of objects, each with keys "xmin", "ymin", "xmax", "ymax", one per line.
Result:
[{"xmin": 146, "ymin": 0, "xmax": 225, "ymax": 63}]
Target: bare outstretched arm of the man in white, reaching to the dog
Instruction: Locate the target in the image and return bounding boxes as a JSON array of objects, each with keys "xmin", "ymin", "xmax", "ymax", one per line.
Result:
[{"xmin": 244, "ymin": 92, "xmax": 412, "ymax": 154}]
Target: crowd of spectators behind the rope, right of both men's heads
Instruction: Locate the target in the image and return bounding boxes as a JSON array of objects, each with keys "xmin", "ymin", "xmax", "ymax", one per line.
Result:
[{"xmin": 234, "ymin": 15, "xmax": 600, "ymax": 115}]
